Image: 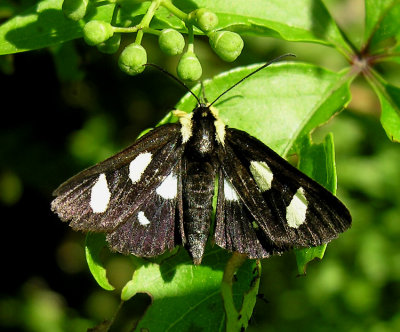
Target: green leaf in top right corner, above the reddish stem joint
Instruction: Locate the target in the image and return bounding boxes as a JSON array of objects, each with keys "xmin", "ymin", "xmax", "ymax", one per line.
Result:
[{"xmin": 364, "ymin": 0, "xmax": 400, "ymax": 53}]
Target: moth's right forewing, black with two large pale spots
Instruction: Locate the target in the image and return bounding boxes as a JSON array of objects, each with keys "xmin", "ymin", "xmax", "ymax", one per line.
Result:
[{"xmin": 217, "ymin": 128, "xmax": 351, "ymax": 257}]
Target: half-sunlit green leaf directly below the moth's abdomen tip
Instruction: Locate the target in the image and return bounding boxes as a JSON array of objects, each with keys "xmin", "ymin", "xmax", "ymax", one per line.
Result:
[{"xmin": 121, "ymin": 247, "xmax": 254, "ymax": 332}]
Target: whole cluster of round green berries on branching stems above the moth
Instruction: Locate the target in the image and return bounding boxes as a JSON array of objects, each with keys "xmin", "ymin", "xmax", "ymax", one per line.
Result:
[{"xmin": 62, "ymin": 0, "xmax": 243, "ymax": 81}]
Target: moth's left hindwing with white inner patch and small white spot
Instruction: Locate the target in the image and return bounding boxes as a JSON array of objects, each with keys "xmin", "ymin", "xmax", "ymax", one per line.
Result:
[{"xmin": 107, "ymin": 161, "xmax": 182, "ymax": 257}]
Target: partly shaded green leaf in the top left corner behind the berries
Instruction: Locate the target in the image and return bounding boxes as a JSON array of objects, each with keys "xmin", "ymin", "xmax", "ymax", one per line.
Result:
[{"xmin": 0, "ymin": 0, "xmax": 115, "ymax": 55}]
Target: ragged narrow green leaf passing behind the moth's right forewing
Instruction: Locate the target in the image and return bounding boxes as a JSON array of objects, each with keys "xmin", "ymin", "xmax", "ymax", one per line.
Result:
[{"xmin": 294, "ymin": 134, "xmax": 337, "ymax": 275}]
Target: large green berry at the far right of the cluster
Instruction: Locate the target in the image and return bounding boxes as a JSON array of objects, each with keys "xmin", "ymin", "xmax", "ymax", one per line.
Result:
[{"xmin": 208, "ymin": 31, "xmax": 243, "ymax": 62}]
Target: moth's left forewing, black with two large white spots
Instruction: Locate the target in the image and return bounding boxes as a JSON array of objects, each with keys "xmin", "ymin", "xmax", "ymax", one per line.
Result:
[{"xmin": 51, "ymin": 124, "xmax": 183, "ymax": 232}]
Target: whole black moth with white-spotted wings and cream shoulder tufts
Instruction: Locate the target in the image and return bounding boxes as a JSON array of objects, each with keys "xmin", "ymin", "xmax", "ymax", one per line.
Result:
[{"xmin": 51, "ymin": 58, "xmax": 351, "ymax": 264}]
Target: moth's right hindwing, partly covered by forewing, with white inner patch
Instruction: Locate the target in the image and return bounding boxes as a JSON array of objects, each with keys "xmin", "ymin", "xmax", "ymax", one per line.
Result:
[{"xmin": 214, "ymin": 169, "xmax": 287, "ymax": 258}]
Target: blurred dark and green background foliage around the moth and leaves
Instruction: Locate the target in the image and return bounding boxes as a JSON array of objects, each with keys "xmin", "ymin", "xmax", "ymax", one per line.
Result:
[{"xmin": 0, "ymin": 0, "xmax": 400, "ymax": 332}]
